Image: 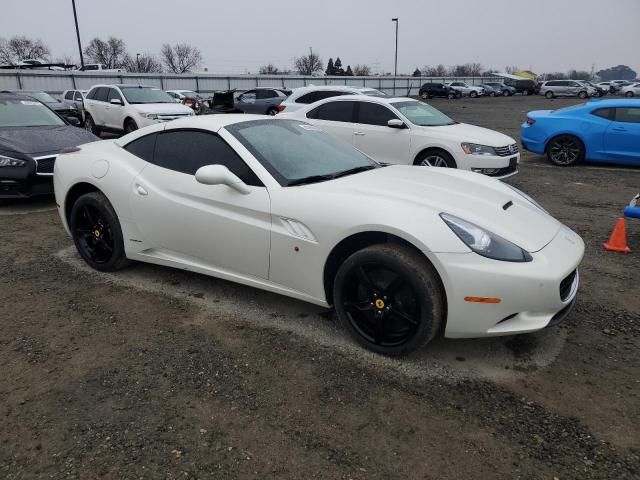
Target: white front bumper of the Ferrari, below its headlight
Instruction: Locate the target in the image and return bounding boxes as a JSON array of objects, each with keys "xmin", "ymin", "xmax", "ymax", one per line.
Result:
[{"xmin": 434, "ymin": 226, "xmax": 584, "ymax": 338}]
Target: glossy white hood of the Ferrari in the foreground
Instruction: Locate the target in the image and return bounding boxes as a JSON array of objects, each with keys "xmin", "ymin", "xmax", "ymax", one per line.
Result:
[{"xmin": 308, "ymin": 165, "xmax": 562, "ymax": 252}]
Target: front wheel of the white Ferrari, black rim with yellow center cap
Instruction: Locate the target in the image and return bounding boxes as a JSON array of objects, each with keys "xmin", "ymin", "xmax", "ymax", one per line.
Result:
[{"xmin": 333, "ymin": 243, "xmax": 445, "ymax": 356}]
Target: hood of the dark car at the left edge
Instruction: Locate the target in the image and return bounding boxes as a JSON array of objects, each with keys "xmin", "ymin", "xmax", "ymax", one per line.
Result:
[{"xmin": 0, "ymin": 125, "xmax": 100, "ymax": 156}]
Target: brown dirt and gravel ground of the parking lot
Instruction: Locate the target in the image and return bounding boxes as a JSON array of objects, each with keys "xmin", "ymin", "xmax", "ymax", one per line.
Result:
[{"xmin": 0, "ymin": 97, "xmax": 640, "ymax": 480}]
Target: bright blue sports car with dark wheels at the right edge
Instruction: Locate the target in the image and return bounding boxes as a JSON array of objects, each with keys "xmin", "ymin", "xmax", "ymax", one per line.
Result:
[{"xmin": 520, "ymin": 99, "xmax": 640, "ymax": 166}]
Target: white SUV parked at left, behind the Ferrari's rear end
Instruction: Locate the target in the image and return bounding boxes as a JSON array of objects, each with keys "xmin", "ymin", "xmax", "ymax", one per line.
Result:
[{"xmin": 84, "ymin": 85, "xmax": 194, "ymax": 135}]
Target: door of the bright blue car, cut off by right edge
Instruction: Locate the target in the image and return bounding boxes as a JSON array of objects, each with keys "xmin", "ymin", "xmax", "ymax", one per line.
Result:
[{"xmin": 605, "ymin": 107, "xmax": 640, "ymax": 163}]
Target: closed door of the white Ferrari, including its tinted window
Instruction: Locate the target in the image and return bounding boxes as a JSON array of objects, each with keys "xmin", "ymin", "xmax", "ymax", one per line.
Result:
[{"xmin": 131, "ymin": 129, "xmax": 271, "ymax": 278}]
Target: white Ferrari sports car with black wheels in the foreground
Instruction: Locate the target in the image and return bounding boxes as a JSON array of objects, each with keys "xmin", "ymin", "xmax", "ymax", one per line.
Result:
[{"xmin": 54, "ymin": 115, "xmax": 584, "ymax": 355}]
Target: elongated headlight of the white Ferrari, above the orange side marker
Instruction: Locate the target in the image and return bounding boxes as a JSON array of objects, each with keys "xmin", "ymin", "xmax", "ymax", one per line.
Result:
[{"xmin": 440, "ymin": 213, "xmax": 533, "ymax": 262}]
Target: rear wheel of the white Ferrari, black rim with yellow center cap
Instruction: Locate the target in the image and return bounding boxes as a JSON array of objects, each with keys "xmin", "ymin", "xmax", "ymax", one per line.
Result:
[{"xmin": 69, "ymin": 192, "xmax": 131, "ymax": 272}]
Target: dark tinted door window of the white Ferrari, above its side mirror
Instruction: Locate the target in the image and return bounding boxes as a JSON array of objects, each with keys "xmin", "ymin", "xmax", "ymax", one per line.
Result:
[{"xmin": 153, "ymin": 130, "xmax": 263, "ymax": 187}]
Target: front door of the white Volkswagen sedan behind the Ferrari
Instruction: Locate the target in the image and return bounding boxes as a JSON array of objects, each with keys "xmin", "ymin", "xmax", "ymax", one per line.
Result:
[{"xmin": 353, "ymin": 101, "xmax": 411, "ymax": 165}]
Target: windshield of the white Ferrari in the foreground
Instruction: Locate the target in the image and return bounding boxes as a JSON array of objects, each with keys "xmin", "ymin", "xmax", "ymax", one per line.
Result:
[{"xmin": 225, "ymin": 120, "xmax": 380, "ymax": 185}]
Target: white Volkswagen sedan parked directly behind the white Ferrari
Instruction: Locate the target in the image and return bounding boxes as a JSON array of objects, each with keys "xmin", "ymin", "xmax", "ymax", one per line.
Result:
[{"xmin": 285, "ymin": 95, "xmax": 520, "ymax": 178}]
